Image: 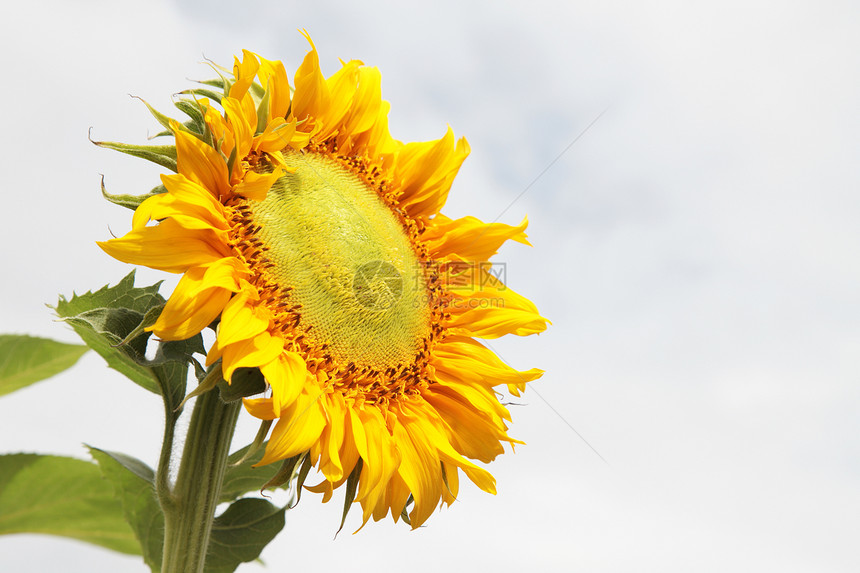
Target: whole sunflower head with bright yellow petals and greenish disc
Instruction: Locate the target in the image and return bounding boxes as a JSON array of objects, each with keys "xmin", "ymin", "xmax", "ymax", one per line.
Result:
[{"xmin": 99, "ymin": 33, "xmax": 547, "ymax": 528}]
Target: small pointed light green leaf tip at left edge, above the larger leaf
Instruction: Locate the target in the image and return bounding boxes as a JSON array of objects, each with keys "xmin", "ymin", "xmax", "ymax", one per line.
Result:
[{"xmin": 0, "ymin": 334, "xmax": 89, "ymax": 396}]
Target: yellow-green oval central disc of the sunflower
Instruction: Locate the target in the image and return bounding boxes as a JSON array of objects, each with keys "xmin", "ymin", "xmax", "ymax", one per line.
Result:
[{"xmin": 246, "ymin": 149, "xmax": 431, "ymax": 371}]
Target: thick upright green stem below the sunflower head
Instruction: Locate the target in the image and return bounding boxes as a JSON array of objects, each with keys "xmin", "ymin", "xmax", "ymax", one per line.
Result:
[{"xmin": 161, "ymin": 380, "xmax": 242, "ymax": 573}]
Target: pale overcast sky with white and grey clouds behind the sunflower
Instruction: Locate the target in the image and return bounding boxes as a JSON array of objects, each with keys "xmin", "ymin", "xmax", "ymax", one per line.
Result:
[{"xmin": 0, "ymin": 0, "xmax": 860, "ymax": 573}]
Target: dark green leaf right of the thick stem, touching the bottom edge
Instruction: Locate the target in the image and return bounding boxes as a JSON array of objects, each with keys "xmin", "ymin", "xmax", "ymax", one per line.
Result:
[{"xmin": 203, "ymin": 498, "xmax": 286, "ymax": 573}]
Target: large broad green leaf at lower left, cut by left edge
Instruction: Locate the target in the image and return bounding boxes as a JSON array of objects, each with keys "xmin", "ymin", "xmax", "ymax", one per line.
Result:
[{"xmin": 0, "ymin": 454, "xmax": 140, "ymax": 555}]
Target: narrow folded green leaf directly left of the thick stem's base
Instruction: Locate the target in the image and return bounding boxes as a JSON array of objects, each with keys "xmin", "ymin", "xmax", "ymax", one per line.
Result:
[{"xmin": 90, "ymin": 447, "xmax": 164, "ymax": 572}]
